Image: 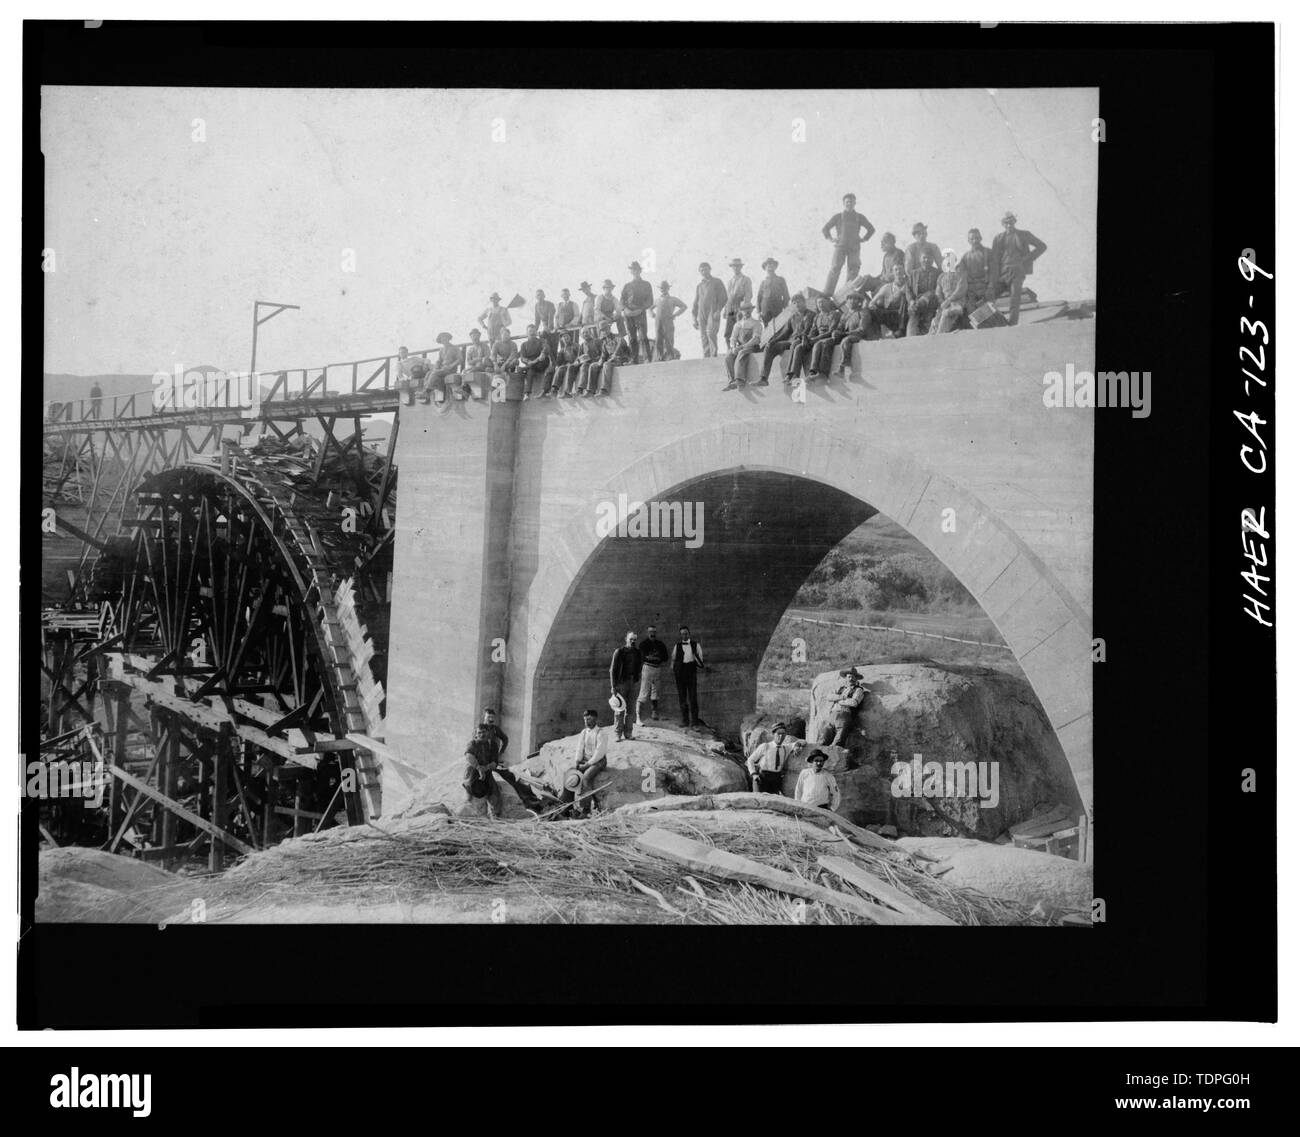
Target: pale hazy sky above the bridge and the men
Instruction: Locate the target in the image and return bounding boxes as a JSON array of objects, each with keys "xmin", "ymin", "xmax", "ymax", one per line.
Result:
[{"xmin": 42, "ymin": 87, "xmax": 1099, "ymax": 374}]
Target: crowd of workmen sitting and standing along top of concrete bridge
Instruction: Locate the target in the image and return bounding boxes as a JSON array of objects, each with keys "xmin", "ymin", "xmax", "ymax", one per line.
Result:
[{"xmin": 397, "ymin": 194, "xmax": 1047, "ymax": 405}]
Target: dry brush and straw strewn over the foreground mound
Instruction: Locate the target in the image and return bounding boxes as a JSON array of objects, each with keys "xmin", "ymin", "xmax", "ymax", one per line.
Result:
[{"xmin": 188, "ymin": 812, "xmax": 1071, "ymax": 925}]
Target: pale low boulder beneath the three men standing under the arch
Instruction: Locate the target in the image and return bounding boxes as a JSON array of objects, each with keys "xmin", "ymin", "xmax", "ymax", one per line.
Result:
[{"xmin": 512, "ymin": 725, "xmax": 749, "ymax": 817}]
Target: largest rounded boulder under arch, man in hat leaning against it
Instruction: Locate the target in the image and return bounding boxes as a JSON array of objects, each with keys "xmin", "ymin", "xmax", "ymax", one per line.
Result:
[{"xmin": 806, "ymin": 663, "xmax": 1083, "ymax": 841}]
